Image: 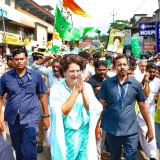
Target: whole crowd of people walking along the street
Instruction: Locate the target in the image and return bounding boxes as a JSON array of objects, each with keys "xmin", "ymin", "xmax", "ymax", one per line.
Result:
[{"xmin": 0, "ymin": 42, "xmax": 160, "ymax": 160}]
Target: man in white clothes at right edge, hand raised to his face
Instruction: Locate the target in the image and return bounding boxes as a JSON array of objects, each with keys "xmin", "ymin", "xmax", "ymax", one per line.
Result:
[{"xmin": 138, "ymin": 63, "xmax": 160, "ymax": 160}]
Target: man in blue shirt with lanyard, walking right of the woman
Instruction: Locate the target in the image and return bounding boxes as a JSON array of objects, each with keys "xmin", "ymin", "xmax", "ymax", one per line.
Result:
[{"xmin": 99, "ymin": 55, "xmax": 153, "ymax": 160}]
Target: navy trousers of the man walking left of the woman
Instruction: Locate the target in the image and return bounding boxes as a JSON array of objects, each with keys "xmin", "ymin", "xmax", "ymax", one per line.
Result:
[{"xmin": 8, "ymin": 116, "xmax": 37, "ymax": 160}]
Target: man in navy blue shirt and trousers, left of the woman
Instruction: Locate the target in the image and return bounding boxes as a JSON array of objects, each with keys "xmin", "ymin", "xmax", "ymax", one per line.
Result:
[{"xmin": 0, "ymin": 49, "xmax": 50, "ymax": 160}]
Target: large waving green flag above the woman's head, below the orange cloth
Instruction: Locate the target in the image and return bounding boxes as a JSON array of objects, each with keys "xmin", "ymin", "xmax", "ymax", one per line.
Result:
[{"xmin": 54, "ymin": 6, "xmax": 100, "ymax": 41}]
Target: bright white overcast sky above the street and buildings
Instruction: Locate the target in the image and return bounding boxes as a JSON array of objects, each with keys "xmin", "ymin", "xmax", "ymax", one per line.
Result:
[{"xmin": 35, "ymin": 0, "xmax": 158, "ymax": 32}]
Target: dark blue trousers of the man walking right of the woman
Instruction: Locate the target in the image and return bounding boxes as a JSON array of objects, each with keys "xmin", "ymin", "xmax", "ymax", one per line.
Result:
[{"xmin": 106, "ymin": 133, "xmax": 138, "ymax": 160}]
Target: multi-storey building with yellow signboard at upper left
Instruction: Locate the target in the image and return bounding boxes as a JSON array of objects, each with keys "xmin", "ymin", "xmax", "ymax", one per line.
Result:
[{"xmin": 0, "ymin": 0, "xmax": 54, "ymax": 53}]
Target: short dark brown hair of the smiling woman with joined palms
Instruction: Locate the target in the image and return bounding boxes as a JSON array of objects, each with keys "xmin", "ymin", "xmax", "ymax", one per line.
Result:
[{"xmin": 60, "ymin": 54, "xmax": 84, "ymax": 72}]
